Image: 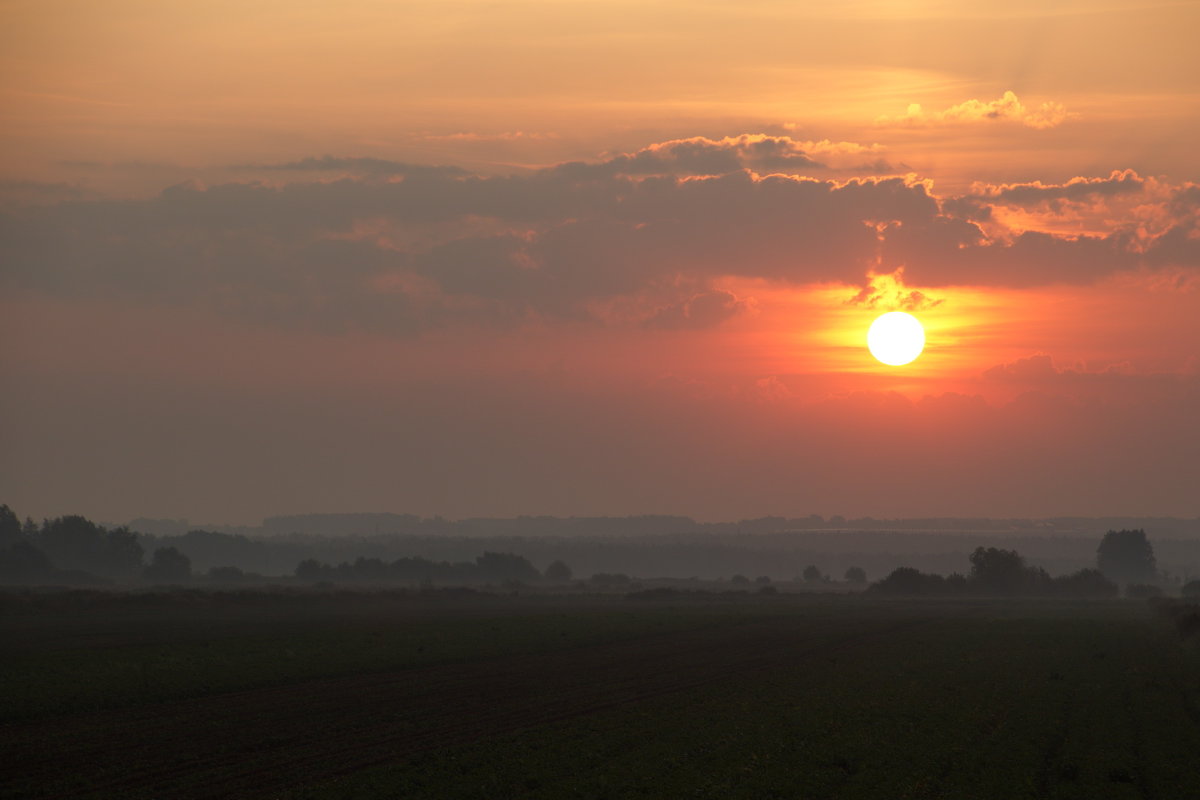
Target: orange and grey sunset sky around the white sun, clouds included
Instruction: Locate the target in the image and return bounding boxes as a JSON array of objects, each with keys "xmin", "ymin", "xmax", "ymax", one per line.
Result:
[{"xmin": 0, "ymin": 0, "xmax": 1200, "ymax": 524}]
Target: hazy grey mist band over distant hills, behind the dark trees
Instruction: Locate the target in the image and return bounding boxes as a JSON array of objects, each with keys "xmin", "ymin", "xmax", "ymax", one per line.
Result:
[{"xmin": 128, "ymin": 513, "xmax": 1200, "ymax": 582}]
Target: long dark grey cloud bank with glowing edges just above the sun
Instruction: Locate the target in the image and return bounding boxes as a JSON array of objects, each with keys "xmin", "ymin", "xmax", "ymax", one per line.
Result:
[{"xmin": 0, "ymin": 140, "xmax": 1200, "ymax": 335}]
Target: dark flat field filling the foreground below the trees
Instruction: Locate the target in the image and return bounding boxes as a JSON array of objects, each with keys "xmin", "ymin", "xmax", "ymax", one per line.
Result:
[{"xmin": 0, "ymin": 593, "xmax": 1200, "ymax": 800}]
